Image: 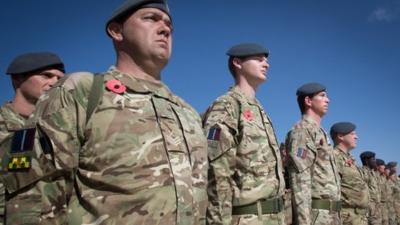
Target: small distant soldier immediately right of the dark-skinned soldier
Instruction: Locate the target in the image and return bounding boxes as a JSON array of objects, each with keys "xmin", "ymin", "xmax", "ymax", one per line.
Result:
[{"xmin": 376, "ymin": 159, "xmax": 389, "ymax": 225}]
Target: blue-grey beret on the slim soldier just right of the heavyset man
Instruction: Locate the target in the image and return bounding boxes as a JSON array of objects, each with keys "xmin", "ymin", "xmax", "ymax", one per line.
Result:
[{"xmin": 226, "ymin": 43, "xmax": 269, "ymax": 57}]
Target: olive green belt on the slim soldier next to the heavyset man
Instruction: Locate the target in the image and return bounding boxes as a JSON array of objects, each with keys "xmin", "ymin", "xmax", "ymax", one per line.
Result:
[{"xmin": 232, "ymin": 197, "xmax": 284, "ymax": 215}]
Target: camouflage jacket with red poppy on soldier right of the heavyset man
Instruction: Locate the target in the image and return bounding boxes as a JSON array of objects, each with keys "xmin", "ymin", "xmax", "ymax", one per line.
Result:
[{"xmin": 203, "ymin": 87, "xmax": 285, "ymax": 224}]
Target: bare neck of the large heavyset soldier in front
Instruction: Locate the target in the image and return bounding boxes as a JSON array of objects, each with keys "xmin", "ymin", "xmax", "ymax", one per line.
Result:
[{"xmin": 115, "ymin": 52, "xmax": 161, "ymax": 82}]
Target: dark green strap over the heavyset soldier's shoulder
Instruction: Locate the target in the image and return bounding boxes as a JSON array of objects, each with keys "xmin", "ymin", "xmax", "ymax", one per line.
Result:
[{"xmin": 86, "ymin": 74, "xmax": 104, "ymax": 123}]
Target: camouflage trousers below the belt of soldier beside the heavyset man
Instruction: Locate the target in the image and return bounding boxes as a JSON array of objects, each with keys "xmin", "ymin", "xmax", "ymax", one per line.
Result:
[{"xmin": 231, "ymin": 211, "xmax": 286, "ymax": 225}]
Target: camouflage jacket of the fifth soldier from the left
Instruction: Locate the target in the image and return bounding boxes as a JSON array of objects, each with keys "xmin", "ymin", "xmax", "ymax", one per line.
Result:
[{"xmin": 334, "ymin": 147, "xmax": 369, "ymax": 209}]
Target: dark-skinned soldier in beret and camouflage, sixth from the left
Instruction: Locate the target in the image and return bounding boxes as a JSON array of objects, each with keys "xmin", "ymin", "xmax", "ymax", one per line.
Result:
[{"xmin": 360, "ymin": 151, "xmax": 382, "ymax": 225}]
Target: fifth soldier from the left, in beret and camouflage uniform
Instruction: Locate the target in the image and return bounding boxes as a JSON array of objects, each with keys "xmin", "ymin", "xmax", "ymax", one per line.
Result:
[{"xmin": 330, "ymin": 122, "xmax": 369, "ymax": 225}]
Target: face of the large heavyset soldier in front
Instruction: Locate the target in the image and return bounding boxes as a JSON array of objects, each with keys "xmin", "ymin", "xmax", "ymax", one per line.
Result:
[{"xmin": 120, "ymin": 8, "xmax": 172, "ymax": 66}]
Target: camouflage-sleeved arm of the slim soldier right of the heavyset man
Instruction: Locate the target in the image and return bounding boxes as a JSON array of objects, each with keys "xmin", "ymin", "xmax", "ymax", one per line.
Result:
[{"xmin": 204, "ymin": 102, "xmax": 237, "ymax": 225}]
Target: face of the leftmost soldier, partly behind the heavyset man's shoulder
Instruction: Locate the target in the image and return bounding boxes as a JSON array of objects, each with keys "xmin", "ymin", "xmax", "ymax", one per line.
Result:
[{"xmin": 19, "ymin": 69, "xmax": 64, "ymax": 103}]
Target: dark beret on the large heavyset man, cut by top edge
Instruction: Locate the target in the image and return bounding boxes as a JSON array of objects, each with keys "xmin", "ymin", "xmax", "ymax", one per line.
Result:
[{"xmin": 106, "ymin": 0, "xmax": 171, "ymax": 34}]
